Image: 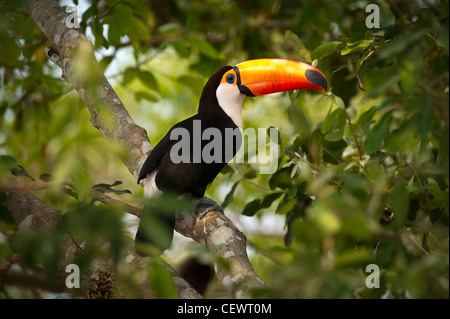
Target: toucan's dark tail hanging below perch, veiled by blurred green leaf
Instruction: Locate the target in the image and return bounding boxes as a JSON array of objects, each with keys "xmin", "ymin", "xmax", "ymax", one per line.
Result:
[{"xmin": 135, "ymin": 203, "xmax": 175, "ymax": 257}]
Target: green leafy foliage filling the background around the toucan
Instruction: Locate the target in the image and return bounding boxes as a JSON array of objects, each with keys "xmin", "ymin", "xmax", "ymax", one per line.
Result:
[{"xmin": 0, "ymin": 0, "xmax": 449, "ymax": 298}]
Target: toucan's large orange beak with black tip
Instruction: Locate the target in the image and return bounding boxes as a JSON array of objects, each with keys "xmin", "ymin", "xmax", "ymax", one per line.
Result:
[{"xmin": 233, "ymin": 59, "xmax": 327, "ymax": 96}]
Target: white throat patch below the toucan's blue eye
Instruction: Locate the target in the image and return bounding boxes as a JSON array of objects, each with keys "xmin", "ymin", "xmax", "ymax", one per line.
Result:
[{"xmin": 216, "ymin": 83, "xmax": 245, "ymax": 129}]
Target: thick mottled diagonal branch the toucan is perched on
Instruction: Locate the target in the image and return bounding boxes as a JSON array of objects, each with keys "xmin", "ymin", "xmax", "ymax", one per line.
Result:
[{"xmin": 23, "ymin": 0, "xmax": 265, "ymax": 297}]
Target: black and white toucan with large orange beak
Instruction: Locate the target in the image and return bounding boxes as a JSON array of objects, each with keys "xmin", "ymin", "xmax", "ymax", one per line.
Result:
[{"xmin": 135, "ymin": 59, "xmax": 327, "ymax": 257}]
